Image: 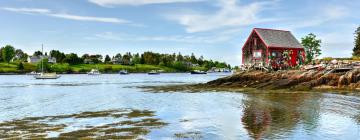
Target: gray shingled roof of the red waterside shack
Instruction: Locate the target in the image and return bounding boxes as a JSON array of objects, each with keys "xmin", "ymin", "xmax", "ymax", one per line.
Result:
[{"xmin": 255, "ymin": 28, "xmax": 303, "ymax": 48}]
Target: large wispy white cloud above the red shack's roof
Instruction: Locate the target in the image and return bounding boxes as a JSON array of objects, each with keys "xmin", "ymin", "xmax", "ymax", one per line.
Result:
[{"xmin": 167, "ymin": 0, "xmax": 276, "ymax": 33}]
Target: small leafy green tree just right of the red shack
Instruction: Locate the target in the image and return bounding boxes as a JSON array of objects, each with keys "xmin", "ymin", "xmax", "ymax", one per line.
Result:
[{"xmin": 301, "ymin": 33, "xmax": 321, "ymax": 63}]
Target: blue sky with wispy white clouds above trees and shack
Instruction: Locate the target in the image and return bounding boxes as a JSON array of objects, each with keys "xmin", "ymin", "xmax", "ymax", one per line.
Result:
[{"xmin": 0, "ymin": 0, "xmax": 360, "ymax": 65}]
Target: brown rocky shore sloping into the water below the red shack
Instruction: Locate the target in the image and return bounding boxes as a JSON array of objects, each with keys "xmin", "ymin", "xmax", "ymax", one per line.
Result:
[{"xmin": 143, "ymin": 69, "xmax": 360, "ymax": 92}]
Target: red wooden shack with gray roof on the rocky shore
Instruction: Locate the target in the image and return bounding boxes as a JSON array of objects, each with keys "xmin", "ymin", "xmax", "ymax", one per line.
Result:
[{"xmin": 242, "ymin": 28, "xmax": 305, "ymax": 69}]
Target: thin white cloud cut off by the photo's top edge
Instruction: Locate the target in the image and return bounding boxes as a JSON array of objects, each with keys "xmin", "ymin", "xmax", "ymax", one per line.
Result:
[{"xmin": 89, "ymin": 0, "xmax": 202, "ymax": 7}]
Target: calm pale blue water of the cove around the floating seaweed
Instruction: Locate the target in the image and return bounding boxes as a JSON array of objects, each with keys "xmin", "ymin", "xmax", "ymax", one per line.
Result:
[{"xmin": 0, "ymin": 74, "xmax": 360, "ymax": 140}]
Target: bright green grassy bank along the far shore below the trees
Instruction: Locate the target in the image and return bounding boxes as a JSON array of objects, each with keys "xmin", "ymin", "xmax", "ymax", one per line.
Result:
[{"xmin": 0, "ymin": 62, "xmax": 204, "ymax": 73}]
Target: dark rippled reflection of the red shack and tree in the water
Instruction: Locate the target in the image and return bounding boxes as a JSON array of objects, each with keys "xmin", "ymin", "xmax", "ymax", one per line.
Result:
[{"xmin": 241, "ymin": 93, "xmax": 320, "ymax": 139}]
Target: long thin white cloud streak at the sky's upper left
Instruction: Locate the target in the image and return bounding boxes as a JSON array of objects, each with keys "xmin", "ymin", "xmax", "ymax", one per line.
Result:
[{"xmin": 2, "ymin": 7, "xmax": 129, "ymax": 23}]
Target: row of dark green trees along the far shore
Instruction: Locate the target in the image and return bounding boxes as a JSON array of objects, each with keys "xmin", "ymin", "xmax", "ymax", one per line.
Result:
[{"xmin": 0, "ymin": 45, "xmax": 231, "ymax": 71}]
